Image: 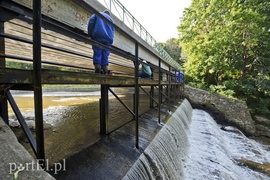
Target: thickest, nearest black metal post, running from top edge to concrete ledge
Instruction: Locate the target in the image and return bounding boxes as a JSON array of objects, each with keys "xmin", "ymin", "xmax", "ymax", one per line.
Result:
[{"xmin": 33, "ymin": 0, "xmax": 45, "ymax": 167}]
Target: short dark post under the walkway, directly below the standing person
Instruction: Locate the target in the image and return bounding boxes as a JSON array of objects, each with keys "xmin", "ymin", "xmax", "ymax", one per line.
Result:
[{"xmin": 100, "ymin": 85, "xmax": 109, "ymax": 134}]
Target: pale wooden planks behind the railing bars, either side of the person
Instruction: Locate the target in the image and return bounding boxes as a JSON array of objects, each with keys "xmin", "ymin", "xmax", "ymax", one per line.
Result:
[{"xmin": 5, "ymin": 19, "xmax": 134, "ymax": 74}]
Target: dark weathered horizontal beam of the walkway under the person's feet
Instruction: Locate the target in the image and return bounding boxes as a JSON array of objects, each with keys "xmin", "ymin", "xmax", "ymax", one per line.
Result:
[{"xmin": 0, "ymin": 68, "xmax": 174, "ymax": 87}]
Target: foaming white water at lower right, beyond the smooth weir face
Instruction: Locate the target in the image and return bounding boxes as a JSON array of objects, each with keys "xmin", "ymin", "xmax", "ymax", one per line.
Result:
[{"xmin": 185, "ymin": 109, "xmax": 270, "ymax": 180}]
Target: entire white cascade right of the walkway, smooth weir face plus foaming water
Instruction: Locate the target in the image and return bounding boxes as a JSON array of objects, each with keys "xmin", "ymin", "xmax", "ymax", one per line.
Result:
[{"xmin": 123, "ymin": 100, "xmax": 270, "ymax": 180}]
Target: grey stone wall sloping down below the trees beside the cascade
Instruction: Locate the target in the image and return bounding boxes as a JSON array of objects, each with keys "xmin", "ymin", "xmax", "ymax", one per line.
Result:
[{"xmin": 184, "ymin": 86, "xmax": 257, "ymax": 136}]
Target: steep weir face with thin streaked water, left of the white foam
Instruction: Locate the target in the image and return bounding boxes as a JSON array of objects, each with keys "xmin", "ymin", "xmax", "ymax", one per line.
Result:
[{"xmin": 123, "ymin": 99, "xmax": 193, "ymax": 180}]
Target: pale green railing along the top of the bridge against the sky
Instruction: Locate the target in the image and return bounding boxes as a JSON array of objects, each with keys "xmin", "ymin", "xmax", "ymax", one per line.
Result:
[{"xmin": 98, "ymin": 0, "xmax": 181, "ymax": 70}]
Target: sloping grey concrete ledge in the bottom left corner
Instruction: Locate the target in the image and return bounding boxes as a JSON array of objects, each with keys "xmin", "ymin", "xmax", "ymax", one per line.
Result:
[{"xmin": 0, "ymin": 117, "xmax": 55, "ymax": 180}]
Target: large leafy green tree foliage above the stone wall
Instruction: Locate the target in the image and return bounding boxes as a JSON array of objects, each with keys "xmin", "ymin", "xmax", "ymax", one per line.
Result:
[{"xmin": 178, "ymin": 0, "xmax": 270, "ymax": 114}]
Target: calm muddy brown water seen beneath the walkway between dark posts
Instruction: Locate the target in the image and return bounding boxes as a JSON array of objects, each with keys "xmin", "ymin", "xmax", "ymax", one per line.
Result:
[{"xmin": 9, "ymin": 92, "xmax": 166, "ymax": 176}]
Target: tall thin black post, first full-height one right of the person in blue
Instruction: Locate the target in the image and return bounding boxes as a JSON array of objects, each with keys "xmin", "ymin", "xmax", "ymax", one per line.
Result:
[{"xmin": 135, "ymin": 42, "xmax": 140, "ymax": 149}]
